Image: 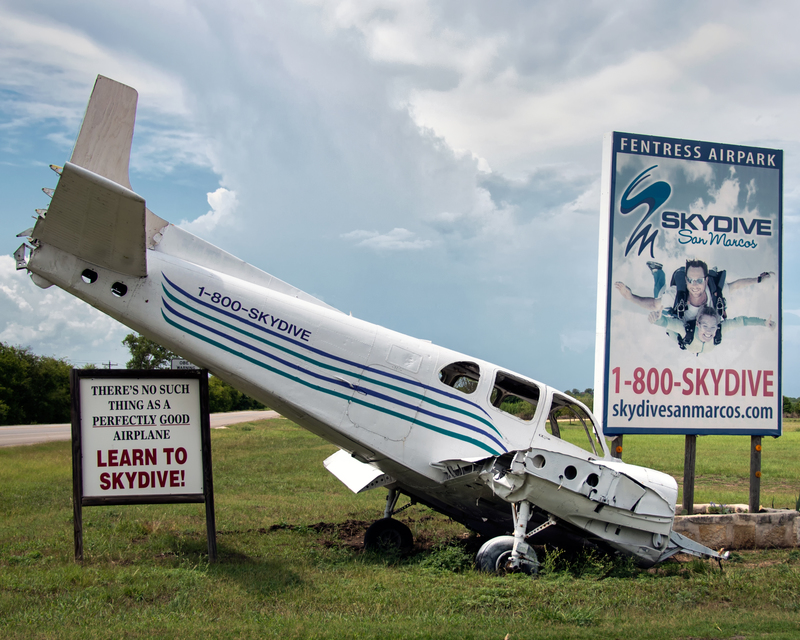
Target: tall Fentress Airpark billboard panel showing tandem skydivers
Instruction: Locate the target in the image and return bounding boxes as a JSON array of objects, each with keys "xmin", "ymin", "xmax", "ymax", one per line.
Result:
[{"xmin": 595, "ymin": 132, "xmax": 783, "ymax": 435}]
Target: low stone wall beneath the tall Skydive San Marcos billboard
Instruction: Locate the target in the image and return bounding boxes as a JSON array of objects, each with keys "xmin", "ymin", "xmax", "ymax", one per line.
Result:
[{"xmin": 673, "ymin": 509, "xmax": 800, "ymax": 549}]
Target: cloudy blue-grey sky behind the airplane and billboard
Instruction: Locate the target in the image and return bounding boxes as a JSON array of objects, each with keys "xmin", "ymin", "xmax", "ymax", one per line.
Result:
[{"xmin": 0, "ymin": 0, "xmax": 800, "ymax": 396}]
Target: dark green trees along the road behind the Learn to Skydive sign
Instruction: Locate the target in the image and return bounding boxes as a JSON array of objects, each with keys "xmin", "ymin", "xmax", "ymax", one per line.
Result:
[{"xmin": 0, "ymin": 333, "xmax": 266, "ymax": 425}]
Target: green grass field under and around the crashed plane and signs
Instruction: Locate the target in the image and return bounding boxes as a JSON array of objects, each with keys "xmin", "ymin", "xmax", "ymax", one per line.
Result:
[{"xmin": 0, "ymin": 420, "xmax": 800, "ymax": 640}]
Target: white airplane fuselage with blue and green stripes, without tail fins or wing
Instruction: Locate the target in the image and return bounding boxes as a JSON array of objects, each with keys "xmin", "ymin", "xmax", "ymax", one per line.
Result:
[{"xmin": 28, "ymin": 220, "xmax": 610, "ymax": 532}]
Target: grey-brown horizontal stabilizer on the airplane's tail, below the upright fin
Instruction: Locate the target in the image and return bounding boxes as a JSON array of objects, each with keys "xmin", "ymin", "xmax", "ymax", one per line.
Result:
[{"xmin": 32, "ymin": 162, "xmax": 147, "ymax": 277}]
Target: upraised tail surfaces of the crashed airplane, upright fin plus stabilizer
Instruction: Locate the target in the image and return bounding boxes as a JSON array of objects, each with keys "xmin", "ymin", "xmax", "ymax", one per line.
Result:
[{"xmin": 31, "ymin": 76, "xmax": 153, "ymax": 277}]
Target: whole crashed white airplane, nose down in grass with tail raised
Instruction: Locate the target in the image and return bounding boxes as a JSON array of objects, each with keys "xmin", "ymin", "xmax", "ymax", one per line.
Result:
[{"xmin": 15, "ymin": 76, "xmax": 721, "ymax": 573}]
